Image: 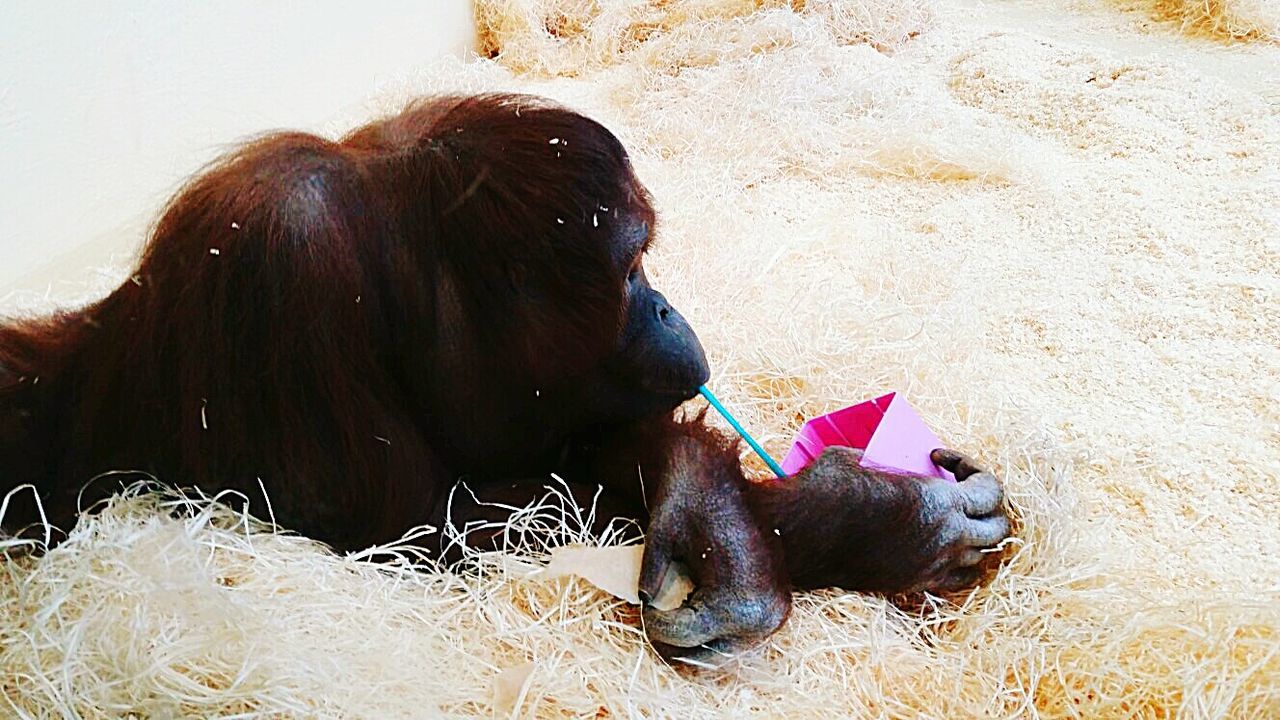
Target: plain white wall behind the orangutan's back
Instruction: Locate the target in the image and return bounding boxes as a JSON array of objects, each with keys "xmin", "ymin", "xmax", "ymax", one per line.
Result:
[{"xmin": 0, "ymin": 0, "xmax": 475, "ymax": 295}]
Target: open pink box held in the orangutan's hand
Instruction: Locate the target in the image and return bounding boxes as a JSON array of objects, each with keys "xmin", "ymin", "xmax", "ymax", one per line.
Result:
[{"xmin": 782, "ymin": 392, "xmax": 955, "ymax": 480}]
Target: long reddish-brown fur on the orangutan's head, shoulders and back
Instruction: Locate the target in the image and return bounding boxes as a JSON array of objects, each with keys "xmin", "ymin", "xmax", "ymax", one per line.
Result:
[{"xmin": 0, "ymin": 96, "xmax": 646, "ymax": 547}]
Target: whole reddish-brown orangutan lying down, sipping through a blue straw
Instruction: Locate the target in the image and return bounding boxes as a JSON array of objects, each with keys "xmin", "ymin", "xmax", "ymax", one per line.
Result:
[{"xmin": 0, "ymin": 95, "xmax": 1009, "ymax": 656}]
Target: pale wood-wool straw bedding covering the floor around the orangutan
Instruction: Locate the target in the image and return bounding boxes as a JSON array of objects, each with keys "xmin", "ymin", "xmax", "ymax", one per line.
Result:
[{"xmin": 0, "ymin": 0, "xmax": 1280, "ymax": 717}]
